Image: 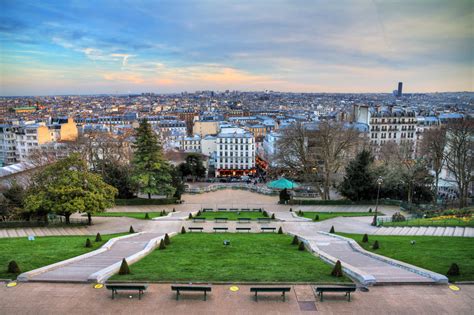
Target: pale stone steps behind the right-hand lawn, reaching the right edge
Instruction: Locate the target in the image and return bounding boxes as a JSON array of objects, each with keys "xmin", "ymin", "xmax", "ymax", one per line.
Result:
[{"xmin": 371, "ymin": 226, "xmax": 474, "ymax": 237}]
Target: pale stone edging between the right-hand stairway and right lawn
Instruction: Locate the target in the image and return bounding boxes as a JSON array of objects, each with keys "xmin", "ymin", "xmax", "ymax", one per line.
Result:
[{"xmin": 326, "ymin": 231, "xmax": 449, "ymax": 284}]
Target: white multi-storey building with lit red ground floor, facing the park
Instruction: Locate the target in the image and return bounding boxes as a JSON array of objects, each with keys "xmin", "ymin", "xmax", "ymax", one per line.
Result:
[{"xmin": 216, "ymin": 128, "xmax": 256, "ymax": 177}]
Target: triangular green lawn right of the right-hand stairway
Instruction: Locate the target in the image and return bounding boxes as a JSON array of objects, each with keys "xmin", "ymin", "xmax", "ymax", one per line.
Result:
[{"xmin": 338, "ymin": 233, "xmax": 474, "ymax": 282}]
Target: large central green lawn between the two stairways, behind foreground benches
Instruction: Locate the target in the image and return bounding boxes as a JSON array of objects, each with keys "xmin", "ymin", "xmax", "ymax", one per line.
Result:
[{"xmin": 112, "ymin": 233, "xmax": 350, "ymax": 283}]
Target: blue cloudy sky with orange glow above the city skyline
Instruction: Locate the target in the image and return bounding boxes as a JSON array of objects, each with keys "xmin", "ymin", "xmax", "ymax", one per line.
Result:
[{"xmin": 0, "ymin": 0, "xmax": 474, "ymax": 96}]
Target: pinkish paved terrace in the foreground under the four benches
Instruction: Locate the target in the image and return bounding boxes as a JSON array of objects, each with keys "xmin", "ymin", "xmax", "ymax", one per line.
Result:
[{"xmin": 0, "ymin": 283, "xmax": 474, "ymax": 315}]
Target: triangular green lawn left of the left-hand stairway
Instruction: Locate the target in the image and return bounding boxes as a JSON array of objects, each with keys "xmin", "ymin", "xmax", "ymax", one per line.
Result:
[{"xmin": 0, "ymin": 234, "xmax": 123, "ymax": 279}]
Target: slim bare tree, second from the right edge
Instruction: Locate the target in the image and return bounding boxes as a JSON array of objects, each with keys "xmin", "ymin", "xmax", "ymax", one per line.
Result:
[{"xmin": 420, "ymin": 127, "xmax": 447, "ymax": 202}]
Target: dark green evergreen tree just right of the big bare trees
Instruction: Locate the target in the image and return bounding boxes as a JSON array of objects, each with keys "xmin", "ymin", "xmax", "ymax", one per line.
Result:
[{"xmin": 339, "ymin": 150, "xmax": 375, "ymax": 201}]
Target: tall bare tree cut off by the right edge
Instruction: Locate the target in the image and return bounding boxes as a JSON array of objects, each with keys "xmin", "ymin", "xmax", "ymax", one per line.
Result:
[{"xmin": 446, "ymin": 118, "xmax": 474, "ymax": 208}]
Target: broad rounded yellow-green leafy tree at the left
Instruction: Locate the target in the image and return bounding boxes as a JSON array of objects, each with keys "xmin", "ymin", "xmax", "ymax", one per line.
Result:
[{"xmin": 25, "ymin": 153, "xmax": 117, "ymax": 224}]
